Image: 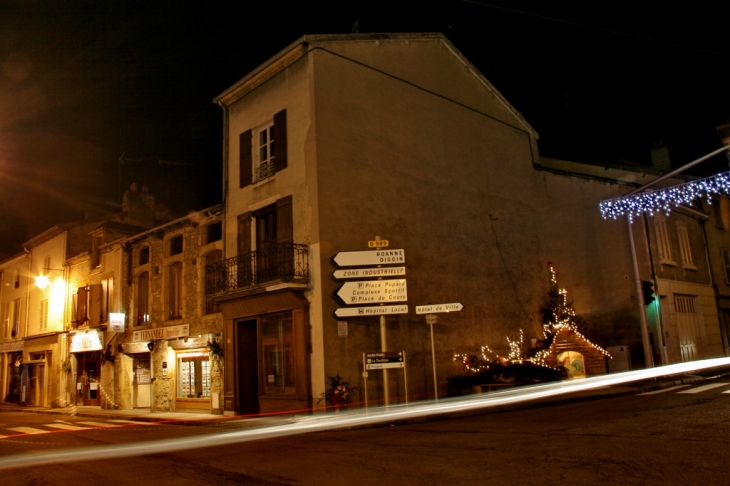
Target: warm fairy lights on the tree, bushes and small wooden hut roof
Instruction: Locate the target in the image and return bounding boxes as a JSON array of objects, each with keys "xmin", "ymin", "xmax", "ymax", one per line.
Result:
[{"xmin": 453, "ymin": 263, "xmax": 611, "ymax": 373}]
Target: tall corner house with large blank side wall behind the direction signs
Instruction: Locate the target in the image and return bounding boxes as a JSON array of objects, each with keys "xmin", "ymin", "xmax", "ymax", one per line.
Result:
[{"xmin": 206, "ymin": 34, "xmax": 692, "ymax": 413}]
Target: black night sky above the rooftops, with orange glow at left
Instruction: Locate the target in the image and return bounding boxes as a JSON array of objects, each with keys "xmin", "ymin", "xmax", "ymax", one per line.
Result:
[{"xmin": 0, "ymin": 0, "xmax": 730, "ymax": 259}]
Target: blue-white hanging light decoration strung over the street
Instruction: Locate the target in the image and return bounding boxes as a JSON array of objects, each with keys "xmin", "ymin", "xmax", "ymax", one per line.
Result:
[{"xmin": 598, "ymin": 172, "xmax": 730, "ymax": 223}]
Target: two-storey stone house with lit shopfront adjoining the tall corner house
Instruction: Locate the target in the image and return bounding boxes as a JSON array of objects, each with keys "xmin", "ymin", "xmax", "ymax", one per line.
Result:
[{"xmin": 111, "ymin": 206, "xmax": 223, "ymax": 413}]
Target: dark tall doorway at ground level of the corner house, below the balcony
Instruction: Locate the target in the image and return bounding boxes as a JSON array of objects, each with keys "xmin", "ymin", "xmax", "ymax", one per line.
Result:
[{"xmin": 236, "ymin": 319, "xmax": 260, "ymax": 414}]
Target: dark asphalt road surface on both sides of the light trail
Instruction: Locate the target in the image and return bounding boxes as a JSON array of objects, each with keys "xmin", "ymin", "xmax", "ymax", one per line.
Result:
[{"xmin": 0, "ymin": 377, "xmax": 730, "ymax": 486}]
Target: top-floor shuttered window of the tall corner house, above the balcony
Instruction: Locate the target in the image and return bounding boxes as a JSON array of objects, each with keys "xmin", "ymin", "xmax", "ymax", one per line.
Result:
[{"xmin": 239, "ymin": 110, "xmax": 287, "ymax": 187}]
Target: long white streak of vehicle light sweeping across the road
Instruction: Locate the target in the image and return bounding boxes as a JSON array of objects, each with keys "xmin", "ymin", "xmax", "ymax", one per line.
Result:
[{"xmin": 0, "ymin": 358, "xmax": 730, "ymax": 470}]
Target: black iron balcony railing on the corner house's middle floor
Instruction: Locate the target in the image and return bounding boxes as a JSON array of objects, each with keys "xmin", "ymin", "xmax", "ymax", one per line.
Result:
[{"xmin": 205, "ymin": 243, "xmax": 309, "ymax": 295}]
